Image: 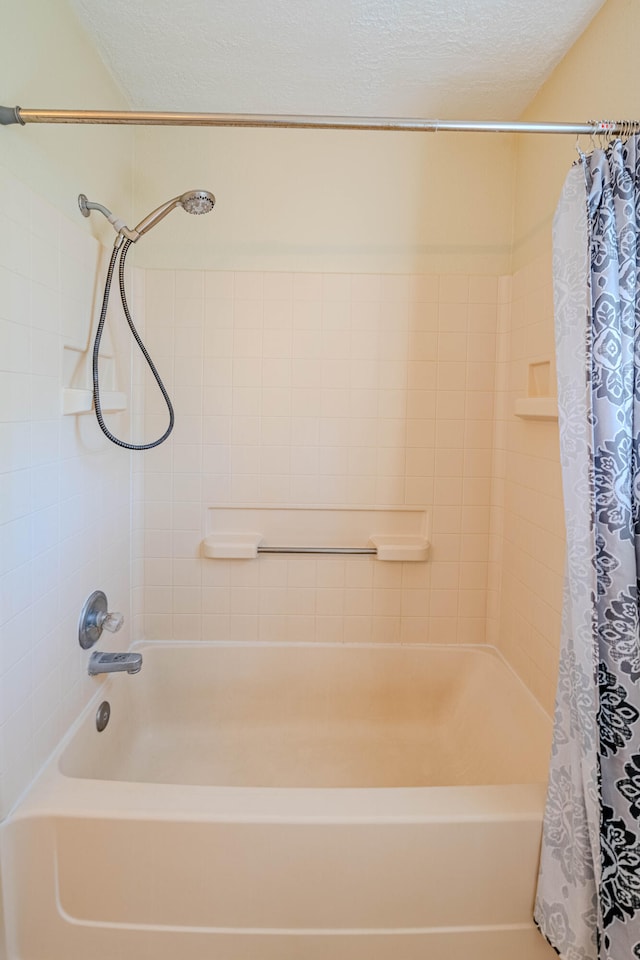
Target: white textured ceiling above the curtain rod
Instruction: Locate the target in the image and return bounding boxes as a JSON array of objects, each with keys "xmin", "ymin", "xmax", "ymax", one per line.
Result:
[{"xmin": 70, "ymin": 0, "xmax": 604, "ymax": 119}]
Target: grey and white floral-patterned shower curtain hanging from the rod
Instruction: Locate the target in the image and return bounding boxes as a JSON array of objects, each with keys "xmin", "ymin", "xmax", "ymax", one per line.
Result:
[{"xmin": 535, "ymin": 137, "xmax": 640, "ymax": 960}]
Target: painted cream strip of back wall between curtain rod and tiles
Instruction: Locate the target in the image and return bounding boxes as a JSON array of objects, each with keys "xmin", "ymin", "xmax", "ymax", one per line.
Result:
[{"xmin": 135, "ymin": 127, "xmax": 514, "ymax": 276}]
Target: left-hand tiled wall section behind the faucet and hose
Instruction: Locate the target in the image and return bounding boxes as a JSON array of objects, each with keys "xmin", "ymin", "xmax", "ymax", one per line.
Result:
[{"xmin": 0, "ymin": 167, "xmax": 130, "ymax": 818}]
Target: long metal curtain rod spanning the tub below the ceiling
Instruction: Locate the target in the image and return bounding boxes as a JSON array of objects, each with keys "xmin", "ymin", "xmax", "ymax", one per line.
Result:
[{"xmin": 0, "ymin": 107, "xmax": 640, "ymax": 137}]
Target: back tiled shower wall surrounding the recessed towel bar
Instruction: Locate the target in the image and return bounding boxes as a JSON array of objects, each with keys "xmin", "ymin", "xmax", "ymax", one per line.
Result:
[{"xmin": 135, "ymin": 270, "xmax": 507, "ymax": 643}]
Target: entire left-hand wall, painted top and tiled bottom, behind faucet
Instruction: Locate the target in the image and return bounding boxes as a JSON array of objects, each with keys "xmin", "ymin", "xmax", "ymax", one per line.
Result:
[{"xmin": 0, "ymin": 0, "xmax": 133, "ymax": 816}]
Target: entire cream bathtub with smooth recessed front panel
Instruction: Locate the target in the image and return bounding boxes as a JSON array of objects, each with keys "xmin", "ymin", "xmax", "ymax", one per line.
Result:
[{"xmin": 2, "ymin": 643, "xmax": 555, "ymax": 960}]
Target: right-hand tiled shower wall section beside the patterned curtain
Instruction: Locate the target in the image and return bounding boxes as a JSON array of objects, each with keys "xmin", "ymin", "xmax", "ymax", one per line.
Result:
[{"xmin": 487, "ymin": 256, "xmax": 565, "ymax": 712}]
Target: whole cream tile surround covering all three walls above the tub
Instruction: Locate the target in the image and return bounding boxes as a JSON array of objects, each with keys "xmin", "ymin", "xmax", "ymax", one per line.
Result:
[{"xmin": 0, "ymin": 173, "xmax": 563, "ymax": 824}]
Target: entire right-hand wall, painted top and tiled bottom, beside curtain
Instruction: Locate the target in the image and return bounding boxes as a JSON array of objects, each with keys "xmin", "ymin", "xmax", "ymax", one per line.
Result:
[{"xmin": 489, "ymin": 0, "xmax": 640, "ymax": 709}]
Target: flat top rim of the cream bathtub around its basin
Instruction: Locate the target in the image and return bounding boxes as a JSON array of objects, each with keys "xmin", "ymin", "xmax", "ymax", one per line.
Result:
[{"xmin": 4, "ymin": 640, "xmax": 550, "ymax": 824}]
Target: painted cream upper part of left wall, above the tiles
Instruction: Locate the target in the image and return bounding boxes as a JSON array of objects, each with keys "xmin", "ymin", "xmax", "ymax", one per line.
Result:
[{"xmin": 0, "ymin": 0, "xmax": 134, "ymax": 243}]
